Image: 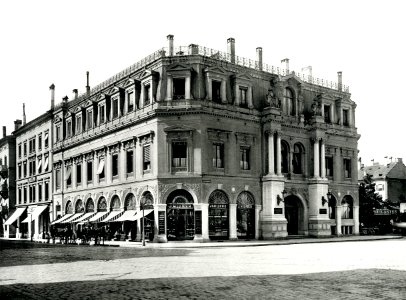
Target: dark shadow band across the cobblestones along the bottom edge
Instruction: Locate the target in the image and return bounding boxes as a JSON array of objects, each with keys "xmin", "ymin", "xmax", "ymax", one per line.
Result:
[{"xmin": 0, "ymin": 269, "xmax": 406, "ymax": 300}]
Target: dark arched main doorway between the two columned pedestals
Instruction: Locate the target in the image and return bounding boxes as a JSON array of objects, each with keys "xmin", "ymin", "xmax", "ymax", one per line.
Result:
[{"xmin": 284, "ymin": 195, "xmax": 303, "ymax": 235}]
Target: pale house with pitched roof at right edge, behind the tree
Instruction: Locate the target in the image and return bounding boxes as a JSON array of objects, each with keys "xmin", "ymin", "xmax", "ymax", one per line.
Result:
[{"xmin": 358, "ymin": 158, "xmax": 406, "ymax": 203}]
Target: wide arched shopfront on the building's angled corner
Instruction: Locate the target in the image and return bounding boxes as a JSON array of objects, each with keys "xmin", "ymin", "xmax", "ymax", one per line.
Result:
[{"xmin": 166, "ymin": 190, "xmax": 195, "ymax": 240}]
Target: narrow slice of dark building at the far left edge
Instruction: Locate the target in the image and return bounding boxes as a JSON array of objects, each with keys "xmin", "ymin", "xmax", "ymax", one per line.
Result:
[{"xmin": 0, "ymin": 126, "xmax": 16, "ymax": 237}]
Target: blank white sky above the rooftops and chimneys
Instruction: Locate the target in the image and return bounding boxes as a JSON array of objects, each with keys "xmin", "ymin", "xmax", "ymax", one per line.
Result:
[{"xmin": 0, "ymin": 0, "xmax": 406, "ymax": 164}]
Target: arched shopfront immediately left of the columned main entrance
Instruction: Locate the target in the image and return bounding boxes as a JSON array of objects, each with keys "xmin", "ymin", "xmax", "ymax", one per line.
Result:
[{"xmin": 237, "ymin": 192, "xmax": 255, "ymax": 239}]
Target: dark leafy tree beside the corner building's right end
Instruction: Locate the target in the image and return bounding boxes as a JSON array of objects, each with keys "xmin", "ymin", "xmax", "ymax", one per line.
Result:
[{"xmin": 359, "ymin": 174, "xmax": 384, "ymax": 226}]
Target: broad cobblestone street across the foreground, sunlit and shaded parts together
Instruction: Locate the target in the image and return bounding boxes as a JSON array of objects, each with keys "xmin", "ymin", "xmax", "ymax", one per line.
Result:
[{"xmin": 0, "ymin": 239, "xmax": 406, "ymax": 299}]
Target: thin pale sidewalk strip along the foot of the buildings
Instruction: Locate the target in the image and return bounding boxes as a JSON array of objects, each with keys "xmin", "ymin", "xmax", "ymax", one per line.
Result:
[{"xmin": 0, "ymin": 235, "xmax": 406, "ymax": 248}]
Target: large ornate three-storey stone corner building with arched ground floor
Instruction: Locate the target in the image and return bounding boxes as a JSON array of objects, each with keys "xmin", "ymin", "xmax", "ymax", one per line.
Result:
[{"xmin": 52, "ymin": 35, "xmax": 359, "ymax": 242}]
